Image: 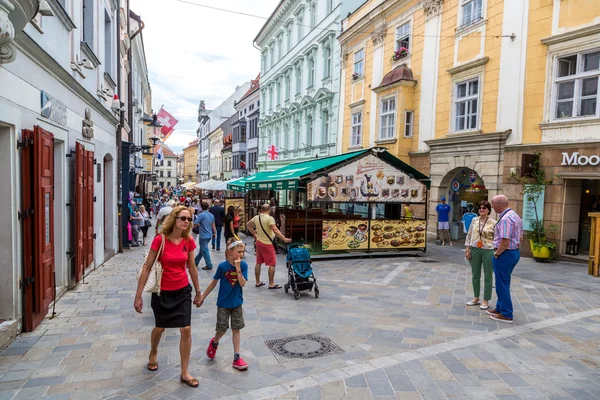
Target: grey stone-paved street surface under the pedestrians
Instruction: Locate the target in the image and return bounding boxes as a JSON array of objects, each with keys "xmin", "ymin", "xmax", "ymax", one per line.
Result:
[{"xmin": 0, "ymin": 236, "xmax": 600, "ymax": 400}]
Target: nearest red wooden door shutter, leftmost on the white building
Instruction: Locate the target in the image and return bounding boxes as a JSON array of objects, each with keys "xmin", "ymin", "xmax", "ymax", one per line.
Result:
[{"xmin": 21, "ymin": 126, "xmax": 54, "ymax": 332}]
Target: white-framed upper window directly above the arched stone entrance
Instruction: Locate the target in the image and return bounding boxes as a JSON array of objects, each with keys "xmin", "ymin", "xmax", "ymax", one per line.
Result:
[{"xmin": 454, "ymin": 78, "xmax": 479, "ymax": 132}]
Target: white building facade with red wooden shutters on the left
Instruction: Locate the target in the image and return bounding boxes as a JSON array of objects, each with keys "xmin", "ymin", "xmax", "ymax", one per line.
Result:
[{"xmin": 0, "ymin": 0, "xmax": 122, "ymax": 331}]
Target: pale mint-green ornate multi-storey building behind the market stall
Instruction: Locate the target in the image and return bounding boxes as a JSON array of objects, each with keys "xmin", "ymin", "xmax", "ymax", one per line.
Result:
[{"xmin": 254, "ymin": 0, "xmax": 362, "ymax": 170}]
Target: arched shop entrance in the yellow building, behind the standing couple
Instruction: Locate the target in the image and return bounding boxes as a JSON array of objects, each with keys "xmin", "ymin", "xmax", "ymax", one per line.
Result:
[{"xmin": 438, "ymin": 167, "xmax": 488, "ymax": 240}]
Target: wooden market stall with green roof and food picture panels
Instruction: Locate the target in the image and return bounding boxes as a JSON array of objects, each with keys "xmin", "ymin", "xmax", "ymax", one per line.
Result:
[{"xmin": 236, "ymin": 148, "xmax": 430, "ymax": 253}]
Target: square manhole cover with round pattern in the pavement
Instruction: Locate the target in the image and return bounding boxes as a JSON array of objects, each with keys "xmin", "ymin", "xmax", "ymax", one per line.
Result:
[{"xmin": 265, "ymin": 333, "xmax": 344, "ymax": 363}]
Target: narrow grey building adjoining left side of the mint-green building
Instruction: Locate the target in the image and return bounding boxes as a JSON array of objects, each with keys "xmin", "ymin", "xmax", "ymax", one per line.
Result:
[{"xmin": 232, "ymin": 75, "xmax": 260, "ymax": 178}]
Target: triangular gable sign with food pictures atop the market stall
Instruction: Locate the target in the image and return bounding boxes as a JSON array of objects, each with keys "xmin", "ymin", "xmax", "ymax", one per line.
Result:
[{"xmin": 307, "ymin": 155, "xmax": 427, "ymax": 203}]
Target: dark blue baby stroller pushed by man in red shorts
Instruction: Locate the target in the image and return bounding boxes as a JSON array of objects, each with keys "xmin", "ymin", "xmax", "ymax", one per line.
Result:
[{"xmin": 283, "ymin": 243, "xmax": 319, "ymax": 300}]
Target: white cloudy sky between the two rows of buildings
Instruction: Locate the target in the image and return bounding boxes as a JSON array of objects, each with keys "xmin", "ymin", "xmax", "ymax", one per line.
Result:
[{"xmin": 131, "ymin": 0, "xmax": 279, "ymax": 152}]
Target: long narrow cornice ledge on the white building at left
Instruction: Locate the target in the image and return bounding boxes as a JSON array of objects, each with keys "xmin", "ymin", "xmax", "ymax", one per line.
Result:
[{"xmin": 15, "ymin": 32, "xmax": 119, "ymax": 125}]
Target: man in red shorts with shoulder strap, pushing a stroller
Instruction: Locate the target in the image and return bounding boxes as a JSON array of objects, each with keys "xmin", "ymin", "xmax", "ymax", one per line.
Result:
[{"xmin": 246, "ymin": 204, "xmax": 292, "ymax": 289}]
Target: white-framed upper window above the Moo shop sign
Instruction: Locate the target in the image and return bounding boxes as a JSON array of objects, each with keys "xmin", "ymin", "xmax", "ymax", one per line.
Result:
[{"xmin": 553, "ymin": 51, "xmax": 600, "ymax": 119}]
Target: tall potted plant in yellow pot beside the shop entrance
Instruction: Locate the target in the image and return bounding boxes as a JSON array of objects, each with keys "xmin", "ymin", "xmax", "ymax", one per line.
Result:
[{"xmin": 510, "ymin": 153, "xmax": 558, "ymax": 262}]
